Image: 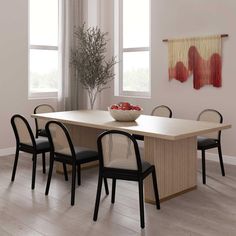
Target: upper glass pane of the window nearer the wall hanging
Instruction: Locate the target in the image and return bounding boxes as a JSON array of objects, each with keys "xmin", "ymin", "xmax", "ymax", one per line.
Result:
[{"xmin": 123, "ymin": 0, "xmax": 149, "ymax": 48}]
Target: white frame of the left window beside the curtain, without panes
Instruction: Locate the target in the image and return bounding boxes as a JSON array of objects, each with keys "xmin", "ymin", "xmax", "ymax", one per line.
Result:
[{"xmin": 28, "ymin": 0, "xmax": 60, "ymax": 99}]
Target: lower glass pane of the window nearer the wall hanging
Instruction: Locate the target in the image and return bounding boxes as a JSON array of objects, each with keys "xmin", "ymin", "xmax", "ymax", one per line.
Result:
[{"xmin": 123, "ymin": 52, "xmax": 149, "ymax": 92}]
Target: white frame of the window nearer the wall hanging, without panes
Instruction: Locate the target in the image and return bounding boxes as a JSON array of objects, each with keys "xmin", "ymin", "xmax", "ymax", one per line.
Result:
[{"xmin": 114, "ymin": 0, "xmax": 151, "ymax": 98}]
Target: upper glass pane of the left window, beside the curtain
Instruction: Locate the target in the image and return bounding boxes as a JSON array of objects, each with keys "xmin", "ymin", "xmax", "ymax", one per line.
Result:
[{"xmin": 30, "ymin": 0, "xmax": 58, "ymax": 46}]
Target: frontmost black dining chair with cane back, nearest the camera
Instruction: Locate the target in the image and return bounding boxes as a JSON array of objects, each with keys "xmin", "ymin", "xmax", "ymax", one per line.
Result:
[{"xmin": 93, "ymin": 130, "xmax": 160, "ymax": 228}]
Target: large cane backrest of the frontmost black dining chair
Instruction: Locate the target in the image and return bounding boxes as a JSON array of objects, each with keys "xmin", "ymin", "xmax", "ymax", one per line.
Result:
[{"xmin": 97, "ymin": 130, "xmax": 142, "ymax": 171}]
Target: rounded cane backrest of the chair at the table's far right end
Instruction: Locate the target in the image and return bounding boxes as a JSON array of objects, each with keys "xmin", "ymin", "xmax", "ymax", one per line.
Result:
[{"xmin": 197, "ymin": 109, "xmax": 223, "ymax": 140}]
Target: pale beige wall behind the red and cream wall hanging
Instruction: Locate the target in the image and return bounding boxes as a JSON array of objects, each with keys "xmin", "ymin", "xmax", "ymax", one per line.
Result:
[{"xmin": 99, "ymin": 0, "xmax": 236, "ymax": 156}]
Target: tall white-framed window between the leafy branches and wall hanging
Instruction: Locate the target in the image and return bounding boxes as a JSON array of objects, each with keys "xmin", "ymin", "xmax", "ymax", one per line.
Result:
[{"xmin": 115, "ymin": 0, "xmax": 150, "ymax": 97}]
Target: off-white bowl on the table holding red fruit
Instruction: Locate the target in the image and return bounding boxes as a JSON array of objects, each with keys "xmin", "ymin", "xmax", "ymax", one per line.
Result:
[{"xmin": 108, "ymin": 107, "xmax": 143, "ymax": 122}]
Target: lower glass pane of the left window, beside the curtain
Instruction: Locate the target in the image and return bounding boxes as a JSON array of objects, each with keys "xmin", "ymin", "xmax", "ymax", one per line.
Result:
[{"xmin": 30, "ymin": 49, "xmax": 58, "ymax": 93}]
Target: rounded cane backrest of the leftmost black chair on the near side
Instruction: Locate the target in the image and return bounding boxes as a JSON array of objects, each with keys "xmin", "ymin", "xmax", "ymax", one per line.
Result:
[{"xmin": 11, "ymin": 114, "xmax": 36, "ymax": 147}]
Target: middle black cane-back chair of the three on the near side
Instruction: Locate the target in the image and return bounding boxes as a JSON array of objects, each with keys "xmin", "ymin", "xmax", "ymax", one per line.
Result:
[{"xmin": 45, "ymin": 121, "xmax": 109, "ymax": 205}]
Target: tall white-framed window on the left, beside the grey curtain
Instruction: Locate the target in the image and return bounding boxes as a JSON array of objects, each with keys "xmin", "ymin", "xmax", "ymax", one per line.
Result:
[{"xmin": 29, "ymin": 0, "xmax": 59, "ymax": 97}]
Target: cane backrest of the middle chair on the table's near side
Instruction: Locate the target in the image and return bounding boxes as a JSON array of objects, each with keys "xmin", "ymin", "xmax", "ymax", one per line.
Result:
[{"xmin": 45, "ymin": 121, "xmax": 75, "ymax": 159}]
